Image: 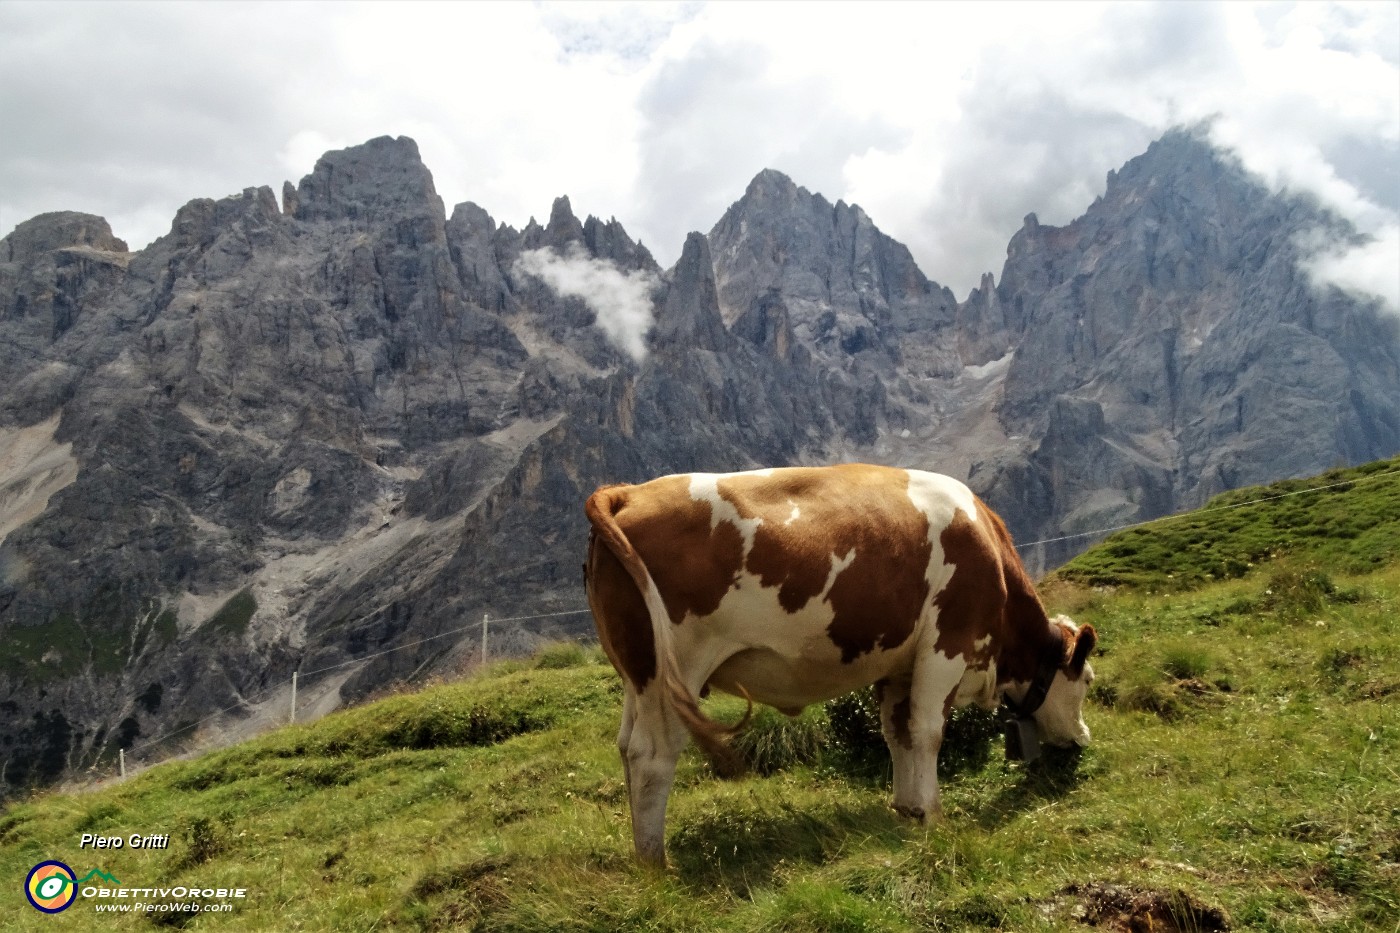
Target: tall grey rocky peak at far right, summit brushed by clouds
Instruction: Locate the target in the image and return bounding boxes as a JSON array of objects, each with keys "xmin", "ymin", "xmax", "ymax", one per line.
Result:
[{"xmin": 965, "ymin": 130, "xmax": 1400, "ymax": 566}]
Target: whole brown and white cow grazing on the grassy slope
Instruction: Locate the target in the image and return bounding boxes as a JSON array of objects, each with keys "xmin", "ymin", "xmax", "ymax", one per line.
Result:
[{"xmin": 585, "ymin": 464, "xmax": 1096, "ymax": 864}]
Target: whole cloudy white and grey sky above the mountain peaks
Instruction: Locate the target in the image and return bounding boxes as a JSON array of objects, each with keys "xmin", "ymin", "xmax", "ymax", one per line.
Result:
[{"xmin": 0, "ymin": 0, "xmax": 1400, "ymax": 301}]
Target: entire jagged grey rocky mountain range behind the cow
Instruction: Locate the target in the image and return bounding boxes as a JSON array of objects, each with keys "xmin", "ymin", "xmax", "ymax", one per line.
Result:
[{"xmin": 0, "ymin": 127, "xmax": 1400, "ymax": 794}]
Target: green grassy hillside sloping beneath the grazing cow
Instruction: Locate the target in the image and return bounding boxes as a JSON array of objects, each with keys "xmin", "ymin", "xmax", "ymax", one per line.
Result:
[{"xmin": 0, "ymin": 462, "xmax": 1400, "ymax": 933}]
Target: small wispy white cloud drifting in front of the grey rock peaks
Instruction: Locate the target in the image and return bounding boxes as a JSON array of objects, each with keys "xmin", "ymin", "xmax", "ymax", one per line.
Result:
[{"xmin": 514, "ymin": 242, "xmax": 661, "ymax": 363}]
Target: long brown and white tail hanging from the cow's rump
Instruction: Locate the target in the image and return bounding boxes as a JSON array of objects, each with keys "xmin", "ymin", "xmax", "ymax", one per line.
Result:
[{"xmin": 584, "ymin": 486, "xmax": 753, "ymax": 778}]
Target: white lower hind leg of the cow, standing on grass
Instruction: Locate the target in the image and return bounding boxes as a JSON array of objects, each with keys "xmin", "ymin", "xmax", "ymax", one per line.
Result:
[{"xmin": 619, "ymin": 681, "xmax": 690, "ymax": 867}]
